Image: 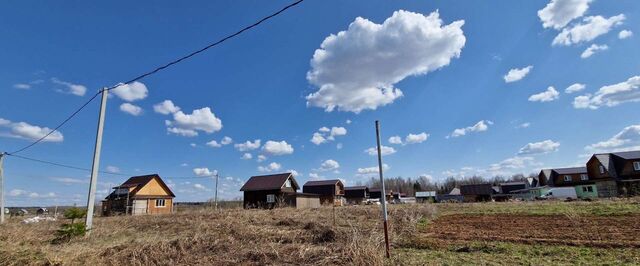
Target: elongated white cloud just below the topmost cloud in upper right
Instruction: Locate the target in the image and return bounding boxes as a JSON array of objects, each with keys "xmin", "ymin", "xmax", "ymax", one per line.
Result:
[{"xmin": 552, "ymin": 14, "xmax": 625, "ymax": 46}]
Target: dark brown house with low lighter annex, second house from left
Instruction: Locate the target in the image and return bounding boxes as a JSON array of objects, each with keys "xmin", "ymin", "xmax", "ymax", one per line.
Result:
[{"xmin": 240, "ymin": 173, "xmax": 320, "ymax": 209}]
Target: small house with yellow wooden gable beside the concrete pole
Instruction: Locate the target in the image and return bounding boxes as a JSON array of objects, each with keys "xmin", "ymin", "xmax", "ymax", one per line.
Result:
[{"xmin": 102, "ymin": 174, "xmax": 176, "ymax": 216}]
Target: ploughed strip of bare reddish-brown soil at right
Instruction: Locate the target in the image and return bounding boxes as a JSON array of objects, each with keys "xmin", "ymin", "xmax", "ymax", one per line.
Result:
[{"xmin": 422, "ymin": 214, "xmax": 640, "ymax": 248}]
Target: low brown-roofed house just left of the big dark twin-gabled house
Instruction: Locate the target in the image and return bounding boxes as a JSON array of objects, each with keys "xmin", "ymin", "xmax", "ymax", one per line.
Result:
[{"xmin": 538, "ymin": 167, "xmax": 593, "ymax": 187}]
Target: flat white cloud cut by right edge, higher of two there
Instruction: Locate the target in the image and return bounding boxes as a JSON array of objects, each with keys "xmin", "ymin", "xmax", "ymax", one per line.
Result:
[{"xmin": 573, "ymin": 76, "xmax": 640, "ymax": 109}]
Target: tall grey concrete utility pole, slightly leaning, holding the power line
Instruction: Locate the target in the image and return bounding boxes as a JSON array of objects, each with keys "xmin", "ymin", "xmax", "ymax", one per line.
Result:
[{"xmin": 85, "ymin": 89, "xmax": 109, "ymax": 235}]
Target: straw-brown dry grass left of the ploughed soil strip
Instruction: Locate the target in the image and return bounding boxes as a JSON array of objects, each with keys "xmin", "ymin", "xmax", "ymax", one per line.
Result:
[{"xmin": 0, "ymin": 205, "xmax": 435, "ymax": 265}]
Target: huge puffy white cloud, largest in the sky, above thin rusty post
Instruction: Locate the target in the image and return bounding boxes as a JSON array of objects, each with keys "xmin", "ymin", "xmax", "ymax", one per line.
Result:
[{"xmin": 306, "ymin": 10, "xmax": 466, "ymax": 113}]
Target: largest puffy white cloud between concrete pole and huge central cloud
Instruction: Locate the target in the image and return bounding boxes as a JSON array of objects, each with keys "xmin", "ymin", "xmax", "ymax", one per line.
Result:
[{"xmin": 165, "ymin": 107, "xmax": 222, "ymax": 137}]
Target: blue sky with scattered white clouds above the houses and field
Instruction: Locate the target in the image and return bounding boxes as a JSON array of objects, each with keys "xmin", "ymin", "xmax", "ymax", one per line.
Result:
[{"xmin": 0, "ymin": 0, "xmax": 640, "ymax": 205}]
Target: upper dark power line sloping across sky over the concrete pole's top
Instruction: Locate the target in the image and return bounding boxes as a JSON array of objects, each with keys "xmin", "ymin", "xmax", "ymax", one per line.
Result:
[{"xmin": 8, "ymin": 0, "xmax": 304, "ymax": 155}]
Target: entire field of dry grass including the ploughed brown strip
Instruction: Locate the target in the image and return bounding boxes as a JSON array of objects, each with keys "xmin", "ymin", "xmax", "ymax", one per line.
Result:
[{"xmin": 0, "ymin": 199, "xmax": 640, "ymax": 265}]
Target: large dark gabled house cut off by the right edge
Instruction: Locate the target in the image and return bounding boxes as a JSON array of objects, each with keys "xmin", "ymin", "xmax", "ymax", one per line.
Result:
[{"xmin": 586, "ymin": 151, "xmax": 640, "ymax": 197}]
